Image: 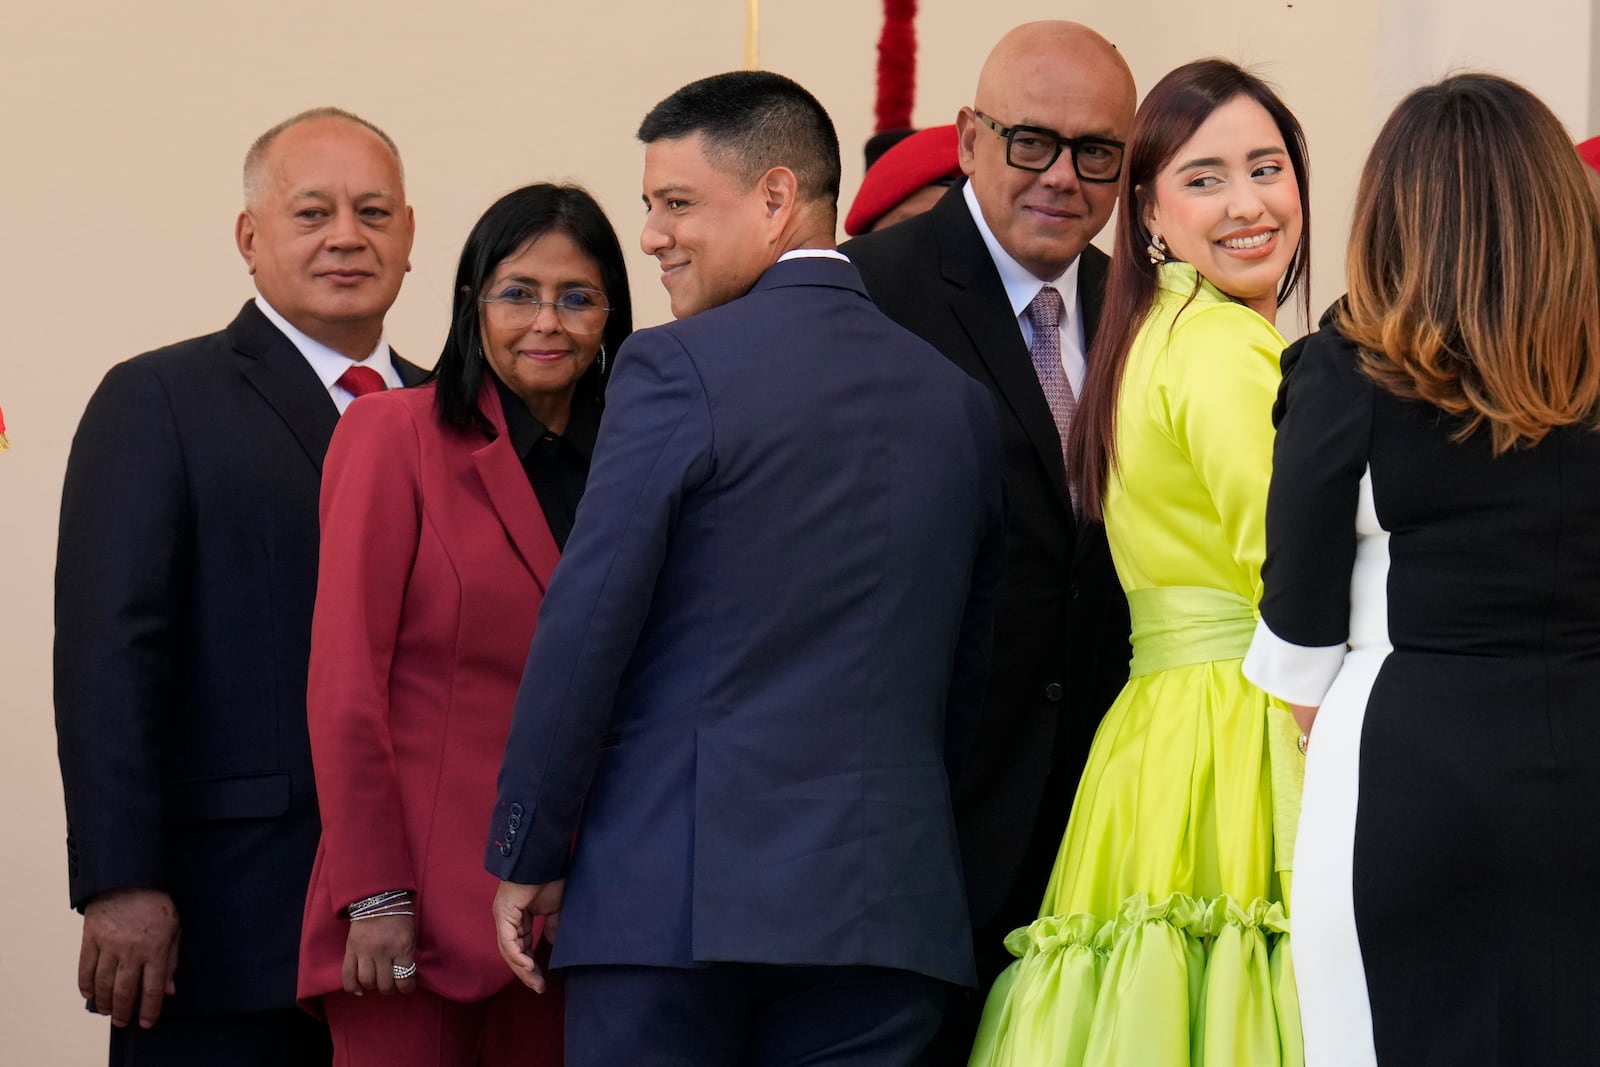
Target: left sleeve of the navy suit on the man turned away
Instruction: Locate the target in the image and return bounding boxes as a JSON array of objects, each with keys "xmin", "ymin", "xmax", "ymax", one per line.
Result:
[{"xmin": 485, "ymin": 330, "xmax": 714, "ymax": 885}]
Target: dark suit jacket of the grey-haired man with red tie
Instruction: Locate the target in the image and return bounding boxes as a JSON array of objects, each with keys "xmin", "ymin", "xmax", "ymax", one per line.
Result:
[{"xmin": 54, "ymin": 302, "xmax": 424, "ymax": 1011}]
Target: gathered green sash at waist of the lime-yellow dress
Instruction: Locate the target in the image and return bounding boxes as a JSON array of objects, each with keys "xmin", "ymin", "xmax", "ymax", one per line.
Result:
[{"xmin": 1128, "ymin": 585, "xmax": 1256, "ymax": 678}]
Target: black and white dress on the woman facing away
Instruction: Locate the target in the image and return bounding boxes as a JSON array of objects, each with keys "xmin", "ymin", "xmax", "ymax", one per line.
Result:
[{"xmin": 1245, "ymin": 326, "xmax": 1600, "ymax": 1067}]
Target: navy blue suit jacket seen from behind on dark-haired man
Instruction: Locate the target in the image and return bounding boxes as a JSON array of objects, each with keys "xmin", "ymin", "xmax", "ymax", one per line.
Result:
[{"xmin": 486, "ymin": 259, "xmax": 1005, "ymax": 984}]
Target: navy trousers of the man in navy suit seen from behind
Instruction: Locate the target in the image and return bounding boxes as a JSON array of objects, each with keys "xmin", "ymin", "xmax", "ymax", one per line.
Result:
[{"xmin": 566, "ymin": 963, "xmax": 950, "ymax": 1067}]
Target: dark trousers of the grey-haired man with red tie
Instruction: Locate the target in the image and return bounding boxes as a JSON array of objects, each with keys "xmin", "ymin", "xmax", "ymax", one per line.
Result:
[{"xmin": 110, "ymin": 1008, "xmax": 333, "ymax": 1067}]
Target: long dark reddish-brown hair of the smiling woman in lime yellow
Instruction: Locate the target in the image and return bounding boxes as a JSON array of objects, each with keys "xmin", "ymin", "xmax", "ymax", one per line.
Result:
[{"xmin": 1067, "ymin": 59, "xmax": 1310, "ymax": 518}]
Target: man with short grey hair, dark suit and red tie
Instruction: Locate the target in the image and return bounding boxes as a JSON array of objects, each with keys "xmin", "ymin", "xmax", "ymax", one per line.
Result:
[{"xmin": 56, "ymin": 109, "xmax": 422, "ymax": 1067}]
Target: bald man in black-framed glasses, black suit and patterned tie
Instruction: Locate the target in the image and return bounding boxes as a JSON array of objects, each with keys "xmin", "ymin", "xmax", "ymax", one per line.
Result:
[{"xmin": 842, "ymin": 22, "xmax": 1134, "ymax": 1064}]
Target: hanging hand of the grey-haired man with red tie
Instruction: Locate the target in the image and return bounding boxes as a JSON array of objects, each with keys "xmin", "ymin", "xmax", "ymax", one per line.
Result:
[{"xmin": 78, "ymin": 889, "xmax": 178, "ymax": 1030}]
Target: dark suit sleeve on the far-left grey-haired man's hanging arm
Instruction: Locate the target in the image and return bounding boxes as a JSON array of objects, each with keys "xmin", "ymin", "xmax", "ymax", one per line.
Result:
[{"xmin": 54, "ymin": 362, "xmax": 192, "ymax": 909}]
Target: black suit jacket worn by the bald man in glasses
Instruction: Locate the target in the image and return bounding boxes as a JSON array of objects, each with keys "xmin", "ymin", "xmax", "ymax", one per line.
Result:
[{"xmin": 842, "ymin": 186, "xmax": 1130, "ymax": 926}]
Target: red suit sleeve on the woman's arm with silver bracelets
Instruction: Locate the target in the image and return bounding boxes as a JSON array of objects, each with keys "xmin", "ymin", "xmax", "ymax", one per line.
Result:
[{"xmin": 306, "ymin": 397, "xmax": 422, "ymax": 910}]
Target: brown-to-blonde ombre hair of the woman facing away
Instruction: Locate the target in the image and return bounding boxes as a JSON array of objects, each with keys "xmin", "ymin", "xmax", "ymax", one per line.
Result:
[{"xmin": 1338, "ymin": 74, "xmax": 1600, "ymax": 454}]
